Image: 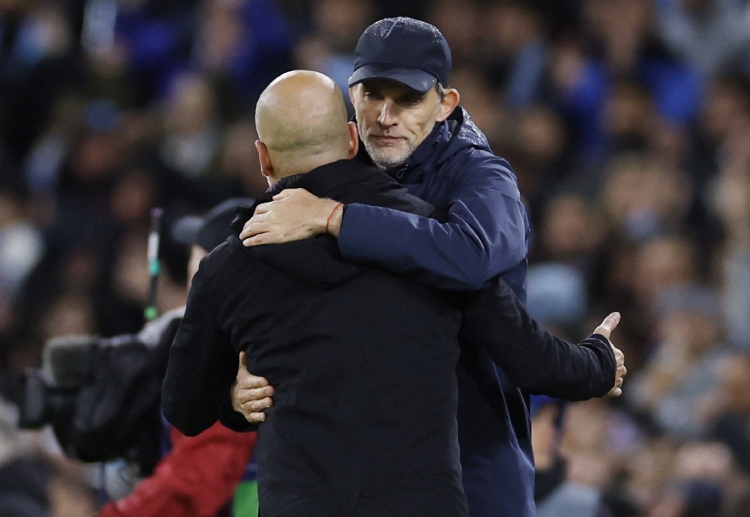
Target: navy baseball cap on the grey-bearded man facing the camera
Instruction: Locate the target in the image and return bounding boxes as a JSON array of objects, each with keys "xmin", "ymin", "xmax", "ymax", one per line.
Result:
[{"xmin": 349, "ymin": 17, "xmax": 452, "ymax": 92}]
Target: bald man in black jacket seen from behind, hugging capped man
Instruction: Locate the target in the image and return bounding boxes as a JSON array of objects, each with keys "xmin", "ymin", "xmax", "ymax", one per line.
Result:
[{"xmin": 162, "ymin": 71, "xmax": 616, "ymax": 517}]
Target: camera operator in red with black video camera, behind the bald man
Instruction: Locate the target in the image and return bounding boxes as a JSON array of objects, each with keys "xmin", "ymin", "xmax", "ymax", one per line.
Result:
[{"xmin": 20, "ymin": 199, "xmax": 257, "ymax": 517}]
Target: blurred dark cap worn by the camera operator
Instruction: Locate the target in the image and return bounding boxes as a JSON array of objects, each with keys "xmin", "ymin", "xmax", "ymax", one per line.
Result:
[{"xmin": 171, "ymin": 197, "xmax": 253, "ymax": 251}]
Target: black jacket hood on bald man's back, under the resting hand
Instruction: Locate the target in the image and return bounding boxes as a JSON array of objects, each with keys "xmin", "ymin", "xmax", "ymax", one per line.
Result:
[{"xmin": 229, "ymin": 160, "xmax": 372, "ymax": 289}]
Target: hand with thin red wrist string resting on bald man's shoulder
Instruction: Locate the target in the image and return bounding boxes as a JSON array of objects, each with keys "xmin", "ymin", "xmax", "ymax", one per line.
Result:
[{"xmin": 240, "ymin": 189, "xmax": 342, "ymax": 246}]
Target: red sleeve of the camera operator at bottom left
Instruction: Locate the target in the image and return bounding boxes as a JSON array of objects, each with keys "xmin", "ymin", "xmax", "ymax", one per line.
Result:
[{"xmin": 99, "ymin": 423, "xmax": 257, "ymax": 517}]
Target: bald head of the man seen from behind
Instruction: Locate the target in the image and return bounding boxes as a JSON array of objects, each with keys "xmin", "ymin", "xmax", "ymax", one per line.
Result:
[{"xmin": 255, "ymin": 70, "xmax": 352, "ymax": 182}]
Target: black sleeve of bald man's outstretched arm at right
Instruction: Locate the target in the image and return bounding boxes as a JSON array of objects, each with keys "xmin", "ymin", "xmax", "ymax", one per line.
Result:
[{"xmin": 461, "ymin": 279, "xmax": 616, "ymax": 401}]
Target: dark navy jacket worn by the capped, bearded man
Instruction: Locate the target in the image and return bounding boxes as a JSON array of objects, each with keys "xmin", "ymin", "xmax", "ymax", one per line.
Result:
[{"xmin": 339, "ymin": 107, "xmax": 535, "ymax": 517}]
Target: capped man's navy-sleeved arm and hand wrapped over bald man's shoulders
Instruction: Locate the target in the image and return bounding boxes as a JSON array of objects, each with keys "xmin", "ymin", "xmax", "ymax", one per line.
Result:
[{"xmin": 240, "ymin": 151, "xmax": 529, "ymax": 290}]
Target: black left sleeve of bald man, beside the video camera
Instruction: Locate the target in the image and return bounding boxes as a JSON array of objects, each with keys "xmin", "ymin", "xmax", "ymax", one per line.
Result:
[{"xmin": 162, "ymin": 255, "xmax": 237, "ymax": 436}]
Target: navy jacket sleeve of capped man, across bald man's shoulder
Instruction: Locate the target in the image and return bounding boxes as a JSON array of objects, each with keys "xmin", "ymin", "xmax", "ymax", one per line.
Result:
[{"xmin": 339, "ymin": 151, "xmax": 529, "ymax": 290}]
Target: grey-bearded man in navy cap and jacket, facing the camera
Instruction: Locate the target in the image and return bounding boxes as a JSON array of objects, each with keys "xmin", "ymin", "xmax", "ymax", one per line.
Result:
[{"xmin": 240, "ymin": 18, "xmax": 534, "ymax": 517}]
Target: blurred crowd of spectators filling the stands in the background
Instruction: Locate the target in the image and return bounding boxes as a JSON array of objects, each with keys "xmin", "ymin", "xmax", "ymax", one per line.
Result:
[{"xmin": 0, "ymin": 0, "xmax": 750, "ymax": 517}]
